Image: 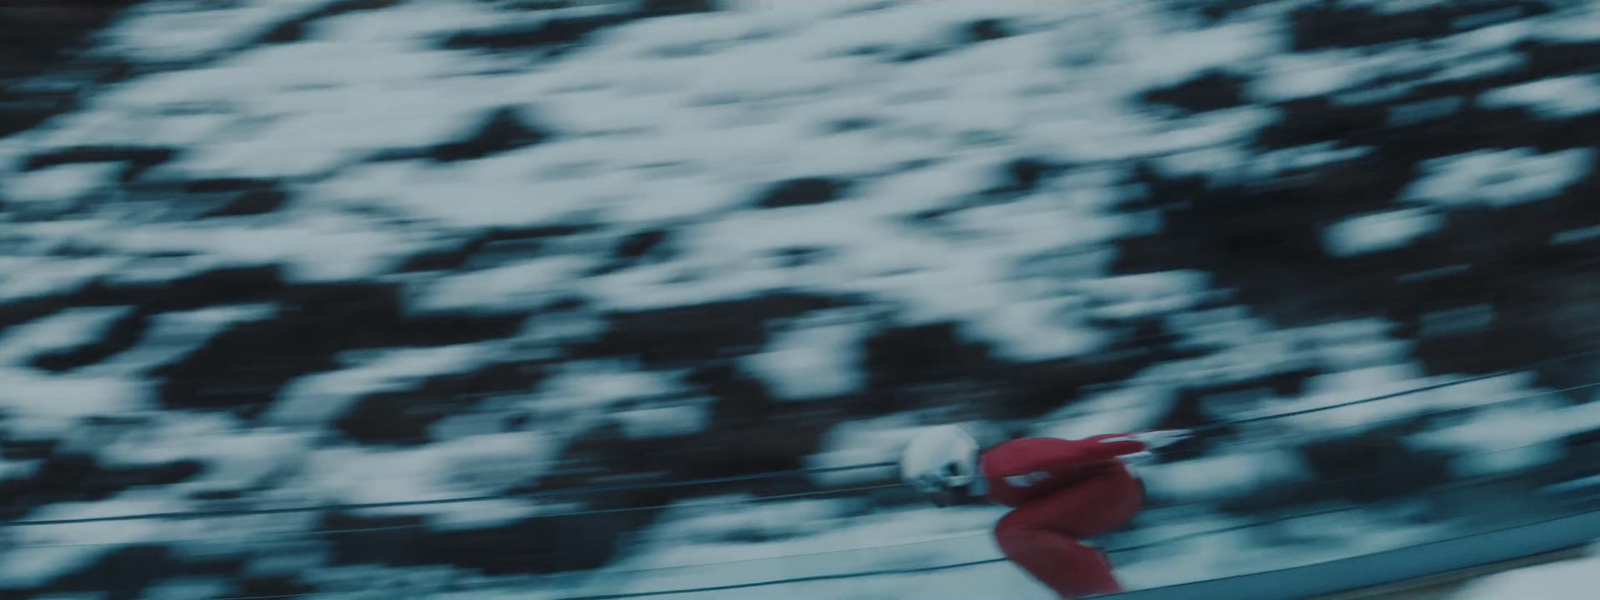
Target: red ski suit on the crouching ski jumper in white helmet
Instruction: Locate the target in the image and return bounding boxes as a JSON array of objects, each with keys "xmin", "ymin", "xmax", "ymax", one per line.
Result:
[{"xmin": 981, "ymin": 435, "xmax": 1146, "ymax": 600}]
